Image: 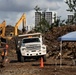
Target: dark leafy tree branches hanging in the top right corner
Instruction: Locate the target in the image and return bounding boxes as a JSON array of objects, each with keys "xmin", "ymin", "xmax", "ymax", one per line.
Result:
[{"xmin": 66, "ymin": 0, "xmax": 76, "ymax": 24}]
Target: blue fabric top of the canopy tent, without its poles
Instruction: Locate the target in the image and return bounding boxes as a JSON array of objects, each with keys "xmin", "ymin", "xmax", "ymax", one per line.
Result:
[{"xmin": 58, "ymin": 31, "xmax": 76, "ymax": 41}]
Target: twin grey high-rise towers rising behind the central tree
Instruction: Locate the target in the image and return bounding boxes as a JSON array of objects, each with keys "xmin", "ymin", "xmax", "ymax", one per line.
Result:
[{"xmin": 35, "ymin": 11, "xmax": 57, "ymax": 26}]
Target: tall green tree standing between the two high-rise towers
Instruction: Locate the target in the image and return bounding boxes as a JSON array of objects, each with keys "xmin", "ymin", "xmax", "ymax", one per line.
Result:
[{"xmin": 34, "ymin": 6, "xmax": 50, "ymax": 33}]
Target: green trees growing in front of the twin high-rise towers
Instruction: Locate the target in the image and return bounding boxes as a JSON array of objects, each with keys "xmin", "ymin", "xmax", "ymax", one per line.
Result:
[{"xmin": 34, "ymin": 5, "xmax": 65, "ymax": 33}]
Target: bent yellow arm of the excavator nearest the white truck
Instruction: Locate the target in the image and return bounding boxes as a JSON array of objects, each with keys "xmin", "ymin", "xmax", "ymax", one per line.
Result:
[{"xmin": 14, "ymin": 14, "xmax": 26, "ymax": 36}]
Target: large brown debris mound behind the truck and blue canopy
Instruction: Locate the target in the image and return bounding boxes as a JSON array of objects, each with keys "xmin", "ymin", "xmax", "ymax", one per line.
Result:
[{"xmin": 44, "ymin": 25, "xmax": 76, "ymax": 55}]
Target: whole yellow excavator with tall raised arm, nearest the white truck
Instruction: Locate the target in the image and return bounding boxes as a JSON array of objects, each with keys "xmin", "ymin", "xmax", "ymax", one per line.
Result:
[{"xmin": 10, "ymin": 14, "xmax": 26, "ymax": 36}]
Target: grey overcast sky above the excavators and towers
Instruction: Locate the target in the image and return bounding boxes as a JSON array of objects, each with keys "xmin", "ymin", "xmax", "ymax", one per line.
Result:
[{"xmin": 0, "ymin": 0, "xmax": 73, "ymax": 29}]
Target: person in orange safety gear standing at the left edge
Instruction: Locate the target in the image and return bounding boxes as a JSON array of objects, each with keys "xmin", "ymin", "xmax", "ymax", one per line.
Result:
[{"xmin": 1, "ymin": 44, "xmax": 8, "ymax": 67}]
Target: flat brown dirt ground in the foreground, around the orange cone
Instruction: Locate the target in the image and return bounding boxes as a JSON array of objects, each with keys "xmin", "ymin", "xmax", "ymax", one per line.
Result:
[{"xmin": 0, "ymin": 51, "xmax": 76, "ymax": 75}]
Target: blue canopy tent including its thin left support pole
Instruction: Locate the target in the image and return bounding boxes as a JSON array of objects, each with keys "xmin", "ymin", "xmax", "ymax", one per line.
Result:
[{"xmin": 58, "ymin": 31, "xmax": 76, "ymax": 67}]
